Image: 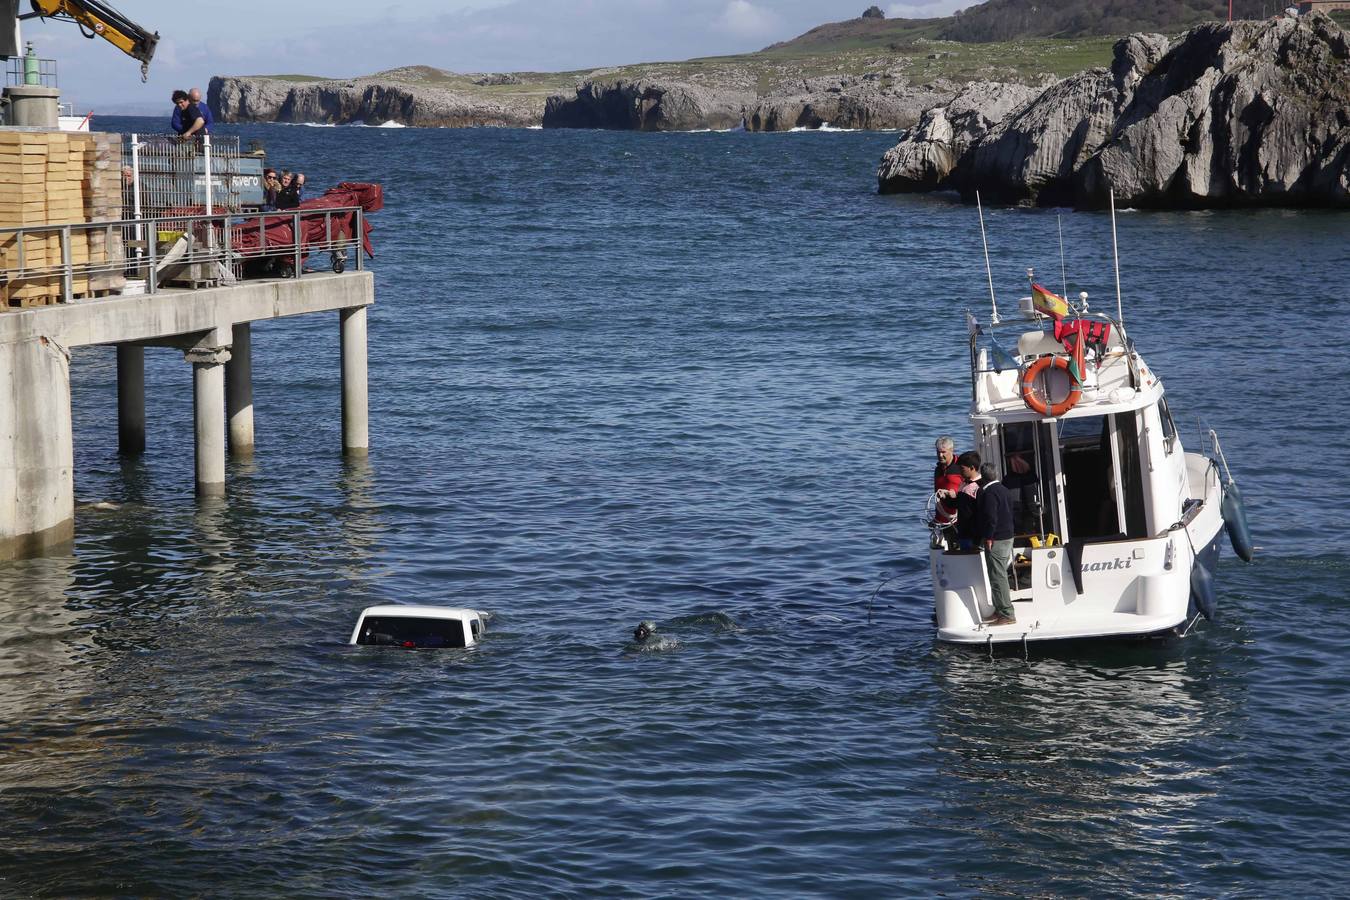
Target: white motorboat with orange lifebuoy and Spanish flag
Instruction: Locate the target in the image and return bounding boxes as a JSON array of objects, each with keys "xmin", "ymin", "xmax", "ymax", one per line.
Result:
[{"xmin": 929, "ymin": 277, "xmax": 1251, "ymax": 649}]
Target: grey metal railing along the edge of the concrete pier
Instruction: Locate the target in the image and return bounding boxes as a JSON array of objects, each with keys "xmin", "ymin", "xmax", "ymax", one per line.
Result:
[{"xmin": 0, "ymin": 206, "xmax": 365, "ymax": 308}]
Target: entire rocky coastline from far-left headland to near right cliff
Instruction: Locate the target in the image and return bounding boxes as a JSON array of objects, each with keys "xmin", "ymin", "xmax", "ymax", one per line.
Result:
[{"xmin": 208, "ymin": 13, "xmax": 1350, "ymax": 208}]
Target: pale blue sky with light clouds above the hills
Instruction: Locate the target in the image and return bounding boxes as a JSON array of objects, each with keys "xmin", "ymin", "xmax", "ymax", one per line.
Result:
[{"xmin": 20, "ymin": 0, "xmax": 972, "ymax": 113}]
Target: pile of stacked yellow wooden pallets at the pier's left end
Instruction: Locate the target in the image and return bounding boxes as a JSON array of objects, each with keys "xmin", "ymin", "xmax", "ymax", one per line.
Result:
[{"xmin": 0, "ymin": 131, "xmax": 122, "ymax": 306}]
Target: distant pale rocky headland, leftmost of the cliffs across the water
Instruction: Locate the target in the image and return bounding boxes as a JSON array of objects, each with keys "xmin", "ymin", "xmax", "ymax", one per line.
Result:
[{"xmin": 207, "ymin": 76, "xmax": 544, "ymax": 128}]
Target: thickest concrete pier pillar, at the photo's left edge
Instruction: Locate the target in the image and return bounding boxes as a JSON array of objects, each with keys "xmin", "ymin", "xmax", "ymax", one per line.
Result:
[{"xmin": 0, "ymin": 337, "xmax": 76, "ymax": 559}]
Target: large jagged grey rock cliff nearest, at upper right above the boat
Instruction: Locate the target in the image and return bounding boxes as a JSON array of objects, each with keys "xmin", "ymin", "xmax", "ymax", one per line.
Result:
[{"xmin": 878, "ymin": 13, "xmax": 1350, "ymax": 208}]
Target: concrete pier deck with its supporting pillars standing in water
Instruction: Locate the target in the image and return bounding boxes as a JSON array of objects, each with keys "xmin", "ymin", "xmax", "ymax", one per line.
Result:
[{"xmin": 0, "ymin": 271, "xmax": 374, "ymax": 559}]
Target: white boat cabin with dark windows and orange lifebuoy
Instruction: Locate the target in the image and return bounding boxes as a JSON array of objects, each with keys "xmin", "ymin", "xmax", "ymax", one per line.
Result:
[{"xmin": 971, "ymin": 306, "xmax": 1187, "ymax": 544}]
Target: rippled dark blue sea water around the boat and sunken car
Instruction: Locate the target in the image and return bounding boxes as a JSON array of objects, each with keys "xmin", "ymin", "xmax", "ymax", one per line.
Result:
[{"xmin": 0, "ymin": 117, "xmax": 1350, "ymax": 897}]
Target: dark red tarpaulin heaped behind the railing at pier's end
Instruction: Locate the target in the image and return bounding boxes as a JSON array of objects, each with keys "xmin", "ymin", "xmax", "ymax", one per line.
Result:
[{"xmin": 231, "ymin": 181, "xmax": 385, "ymax": 256}]
